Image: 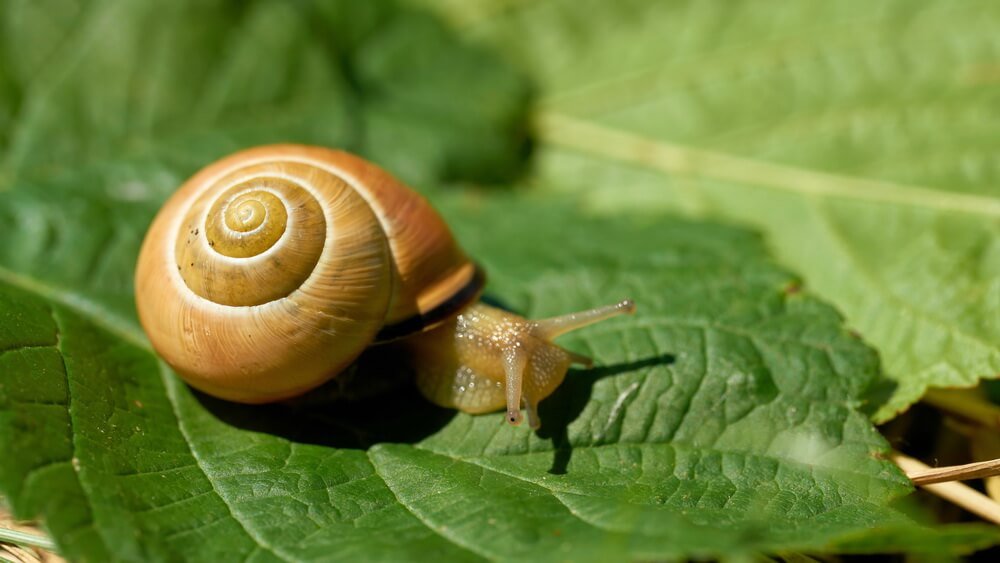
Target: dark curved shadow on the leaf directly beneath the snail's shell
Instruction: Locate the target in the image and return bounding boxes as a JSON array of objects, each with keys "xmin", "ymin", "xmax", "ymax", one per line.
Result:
[{"xmin": 194, "ymin": 354, "xmax": 455, "ymax": 450}]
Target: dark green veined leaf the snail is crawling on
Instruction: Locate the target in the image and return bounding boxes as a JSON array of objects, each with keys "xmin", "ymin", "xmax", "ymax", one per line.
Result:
[{"xmin": 0, "ymin": 186, "xmax": 1000, "ymax": 560}]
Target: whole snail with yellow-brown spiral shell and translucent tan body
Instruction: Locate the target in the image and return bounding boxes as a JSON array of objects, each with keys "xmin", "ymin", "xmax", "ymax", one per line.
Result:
[{"xmin": 136, "ymin": 145, "xmax": 634, "ymax": 428}]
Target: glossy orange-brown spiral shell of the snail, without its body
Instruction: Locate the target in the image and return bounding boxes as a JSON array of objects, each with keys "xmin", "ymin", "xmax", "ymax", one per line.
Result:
[{"xmin": 136, "ymin": 145, "xmax": 478, "ymax": 403}]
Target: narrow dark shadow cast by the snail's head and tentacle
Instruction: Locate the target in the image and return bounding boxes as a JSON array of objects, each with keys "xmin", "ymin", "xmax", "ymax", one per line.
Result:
[{"xmin": 538, "ymin": 354, "xmax": 676, "ymax": 475}]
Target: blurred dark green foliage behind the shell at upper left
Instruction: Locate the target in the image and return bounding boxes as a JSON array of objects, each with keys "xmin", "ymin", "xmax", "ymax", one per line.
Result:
[{"xmin": 0, "ymin": 0, "xmax": 531, "ymax": 192}]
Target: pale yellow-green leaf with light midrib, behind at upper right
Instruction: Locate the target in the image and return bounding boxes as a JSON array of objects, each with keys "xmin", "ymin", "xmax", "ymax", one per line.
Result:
[{"xmin": 412, "ymin": 0, "xmax": 1000, "ymax": 419}]
